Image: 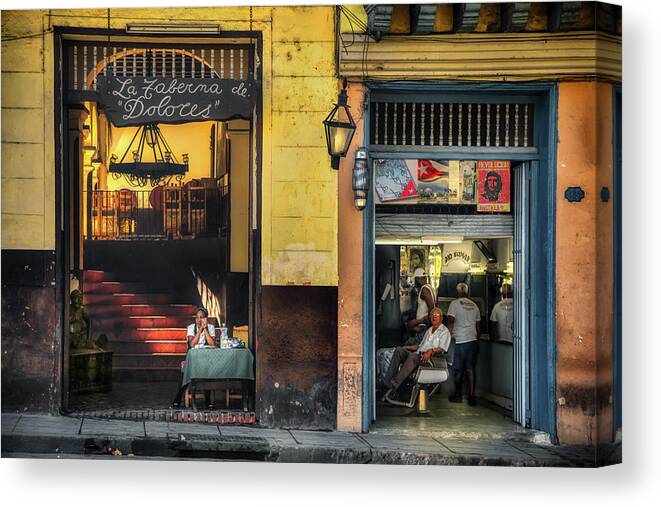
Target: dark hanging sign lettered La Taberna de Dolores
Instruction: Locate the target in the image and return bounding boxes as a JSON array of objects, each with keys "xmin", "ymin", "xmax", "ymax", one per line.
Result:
[{"xmin": 97, "ymin": 76, "xmax": 256, "ymax": 127}]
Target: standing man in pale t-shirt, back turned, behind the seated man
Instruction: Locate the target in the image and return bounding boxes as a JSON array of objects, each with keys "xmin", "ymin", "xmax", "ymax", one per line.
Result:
[{"xmin": 448, "ymin": 283, "xmax": 480, "ymax": 406}]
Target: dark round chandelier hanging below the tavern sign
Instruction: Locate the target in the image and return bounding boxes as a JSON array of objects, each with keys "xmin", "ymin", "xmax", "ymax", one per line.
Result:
[{"xmin": 108, "ymin": 123, "xmax": 188, "ymax": 187}]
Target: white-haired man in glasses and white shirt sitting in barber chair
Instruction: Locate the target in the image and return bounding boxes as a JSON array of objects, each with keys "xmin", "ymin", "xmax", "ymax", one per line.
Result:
[{"xmin": 385, "ymin": 307, "xmax": 451, "ymax": 401}]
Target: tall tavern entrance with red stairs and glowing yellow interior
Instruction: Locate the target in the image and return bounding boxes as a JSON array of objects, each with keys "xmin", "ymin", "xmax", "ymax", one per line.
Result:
[{"xmin": 56, "ymin": 33, "xmax": 261, "ymax": 423}]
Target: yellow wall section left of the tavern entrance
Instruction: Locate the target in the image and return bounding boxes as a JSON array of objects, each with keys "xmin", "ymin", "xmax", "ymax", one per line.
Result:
[{"xmin": 1, "ymin": 11, "xmax": 55, "ymax": 250}]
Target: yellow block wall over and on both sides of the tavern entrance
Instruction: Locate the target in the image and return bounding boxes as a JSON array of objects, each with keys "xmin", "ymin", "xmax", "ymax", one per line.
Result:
[{"xmin": 2, "ymin": 6, "xmax": 338, "ymax": 286}]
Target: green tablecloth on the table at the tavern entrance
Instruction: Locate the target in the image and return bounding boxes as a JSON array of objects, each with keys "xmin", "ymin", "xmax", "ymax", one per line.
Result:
[{"xmin": 181, "ymin": 348, "xmax": 255, "ymax": 386}]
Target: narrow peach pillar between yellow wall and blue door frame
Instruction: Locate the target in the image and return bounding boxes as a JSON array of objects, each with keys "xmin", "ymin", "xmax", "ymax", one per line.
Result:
[{"xmin": 337, "ymin": 84, "xmax": 364, "ymax": 431}]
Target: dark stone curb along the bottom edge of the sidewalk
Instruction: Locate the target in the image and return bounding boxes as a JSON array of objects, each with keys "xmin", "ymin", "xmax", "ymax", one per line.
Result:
[{"xmin": 2, "ymin": 433, "xmax": 622, "ymax": 468}]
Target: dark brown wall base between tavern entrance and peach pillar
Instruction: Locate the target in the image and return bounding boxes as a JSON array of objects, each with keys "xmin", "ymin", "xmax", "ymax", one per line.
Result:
[{"xmin": 256, "ymin": 286, "xmax": 337, "ymax": 430}]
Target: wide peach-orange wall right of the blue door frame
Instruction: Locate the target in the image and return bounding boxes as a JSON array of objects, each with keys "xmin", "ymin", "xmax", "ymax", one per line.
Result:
[{"xmin": 556, "ymin": 81, "xmax": 613, "ymax": 444}]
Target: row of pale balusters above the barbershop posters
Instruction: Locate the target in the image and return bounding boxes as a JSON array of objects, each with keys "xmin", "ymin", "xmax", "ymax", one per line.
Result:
[{"xmin": 370, "ymin": 102, "xmax": 534, "ymax": 149}]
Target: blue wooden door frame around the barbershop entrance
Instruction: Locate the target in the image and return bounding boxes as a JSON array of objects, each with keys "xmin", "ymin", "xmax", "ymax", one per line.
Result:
[{"xmin": 362, "ymin": 81, "xmax": 558, "ymax": 442}]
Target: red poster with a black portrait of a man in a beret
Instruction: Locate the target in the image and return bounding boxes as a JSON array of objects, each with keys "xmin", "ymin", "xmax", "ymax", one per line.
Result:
[{"xmin": 477, "ymin": 160, "xmax": 510, "ymax": 212}]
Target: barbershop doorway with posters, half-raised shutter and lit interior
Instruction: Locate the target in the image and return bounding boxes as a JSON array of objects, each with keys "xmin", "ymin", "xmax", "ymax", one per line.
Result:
[{"xmin": 368, "ymin": 157, "xmax": 530, "ymax": 436}]
